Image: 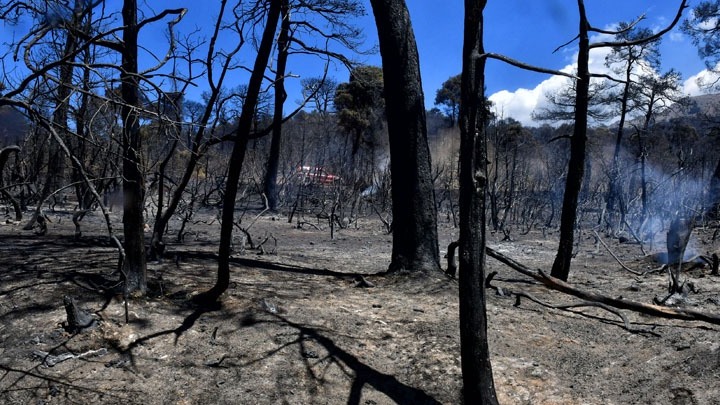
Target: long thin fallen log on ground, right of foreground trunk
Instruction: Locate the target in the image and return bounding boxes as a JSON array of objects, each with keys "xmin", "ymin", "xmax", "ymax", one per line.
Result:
[{"xmin": 485, "ymin": 247, "xmax": 720, "ymax": 325}]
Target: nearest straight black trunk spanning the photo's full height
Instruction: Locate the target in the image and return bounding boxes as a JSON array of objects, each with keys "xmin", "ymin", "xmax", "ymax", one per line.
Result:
[{"xmin": 458, "ymin": 0, "xmax": 498, "ymax": 404}]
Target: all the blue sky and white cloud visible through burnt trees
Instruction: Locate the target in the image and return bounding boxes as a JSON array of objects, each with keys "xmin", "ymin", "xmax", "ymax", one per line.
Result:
[{"xmin": 3, "ymin": 0, "xmax": 716, "ymax": 125}]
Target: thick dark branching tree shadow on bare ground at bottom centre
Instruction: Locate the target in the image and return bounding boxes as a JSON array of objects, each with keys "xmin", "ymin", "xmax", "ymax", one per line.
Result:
[{"xmin": 242, "ymin": 311, "xmax": 440, "ymax": 405}]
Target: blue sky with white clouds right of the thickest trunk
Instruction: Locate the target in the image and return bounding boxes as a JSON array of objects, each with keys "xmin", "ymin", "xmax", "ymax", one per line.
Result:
[{"xmin": 408, "ymin": 0, "xmax": 705, "ymax": 125}]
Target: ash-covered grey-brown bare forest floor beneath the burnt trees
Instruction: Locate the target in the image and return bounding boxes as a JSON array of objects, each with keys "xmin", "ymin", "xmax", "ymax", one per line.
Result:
[{"xmin": 0, "ymin": 208, "xmax": 720, "ymax": 405}]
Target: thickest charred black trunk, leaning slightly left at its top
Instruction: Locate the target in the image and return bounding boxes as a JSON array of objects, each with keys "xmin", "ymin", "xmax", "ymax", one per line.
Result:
[{"xmin": 370, "ymin": 0, "xmax": 440, "ymax": 272}]
